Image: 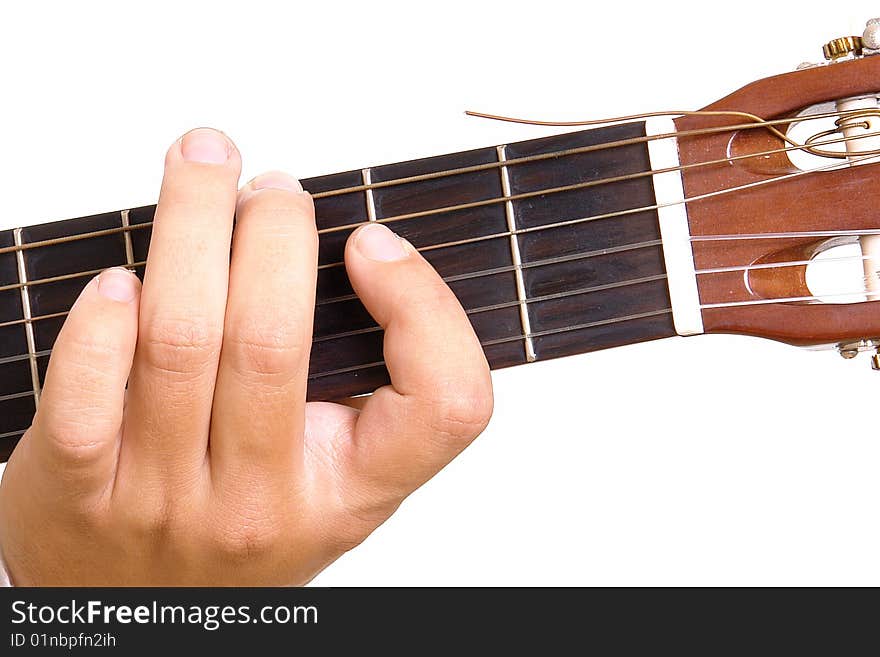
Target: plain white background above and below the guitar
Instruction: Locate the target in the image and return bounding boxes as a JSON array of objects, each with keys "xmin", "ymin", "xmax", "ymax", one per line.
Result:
[{"xmin": 0, "ymin": 0, "xmax": 880, "ymax": 586}]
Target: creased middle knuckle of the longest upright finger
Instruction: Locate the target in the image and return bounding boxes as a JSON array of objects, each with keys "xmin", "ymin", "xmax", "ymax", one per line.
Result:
[{"xmin": 141, "ymin": 319, "xmax": 223, "ymax": 375}]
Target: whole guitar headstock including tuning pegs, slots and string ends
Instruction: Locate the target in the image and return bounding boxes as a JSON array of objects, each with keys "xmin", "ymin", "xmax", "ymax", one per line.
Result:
[{"xmin": 675, "ymin": 22, "xmax": 880, "ymax": 367}]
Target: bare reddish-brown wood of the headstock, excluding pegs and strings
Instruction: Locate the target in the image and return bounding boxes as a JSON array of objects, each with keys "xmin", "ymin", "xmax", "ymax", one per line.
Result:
[{"xmin": 675, "ymin": 56, "xmax": 880, "ymax": 345}]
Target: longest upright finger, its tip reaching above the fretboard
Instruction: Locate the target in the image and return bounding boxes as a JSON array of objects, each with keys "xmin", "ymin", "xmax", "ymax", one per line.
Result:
[{"xmin": 121, "ymin": 128, "xmax": 241, "ymax": 481}]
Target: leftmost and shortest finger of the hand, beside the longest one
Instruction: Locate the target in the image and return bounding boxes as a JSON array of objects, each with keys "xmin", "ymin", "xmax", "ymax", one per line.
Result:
[{"xmin": 26, "ymin": 269, "xmax": 140, "ymax": 487}]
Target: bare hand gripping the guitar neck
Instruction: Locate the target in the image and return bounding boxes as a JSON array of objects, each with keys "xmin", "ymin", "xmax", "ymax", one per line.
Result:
[{"xmin": 0, "ymin": 129, "xmax": 492, "ymax": 585}]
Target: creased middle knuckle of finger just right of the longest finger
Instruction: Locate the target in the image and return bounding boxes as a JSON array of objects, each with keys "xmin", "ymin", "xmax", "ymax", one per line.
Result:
[{"xmin": 227, "ymin": 316, "xmax": 311, "ymax": 376}]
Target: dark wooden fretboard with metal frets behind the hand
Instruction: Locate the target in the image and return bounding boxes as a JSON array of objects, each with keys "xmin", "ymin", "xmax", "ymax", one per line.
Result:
[{"xmin": 0, "ymin": 122, "xmax": 675, "ymax": 460}]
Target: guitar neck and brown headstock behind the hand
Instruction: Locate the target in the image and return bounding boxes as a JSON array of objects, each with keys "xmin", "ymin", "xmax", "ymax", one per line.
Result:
[{"xmin": 0, "ymin": 23, "xmax": 880, "ymax": 466}]
